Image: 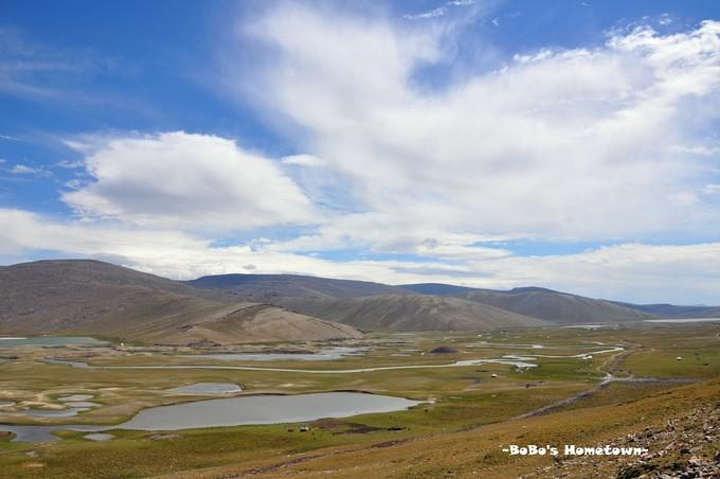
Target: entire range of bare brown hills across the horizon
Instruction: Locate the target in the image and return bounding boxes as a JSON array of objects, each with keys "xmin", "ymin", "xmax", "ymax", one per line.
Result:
[{"xmin": 0, "ymin": 260, "xmax": 720, "ymax": 344}]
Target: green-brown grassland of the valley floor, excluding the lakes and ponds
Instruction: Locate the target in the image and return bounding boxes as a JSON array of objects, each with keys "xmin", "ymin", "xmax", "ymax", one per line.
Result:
[{"xmin": 0, "ymin": 324, "xmax": 720, "ymax": 478}]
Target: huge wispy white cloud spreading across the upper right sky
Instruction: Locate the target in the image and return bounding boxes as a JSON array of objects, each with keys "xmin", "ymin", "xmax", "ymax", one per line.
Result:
[{"xmin": 236, "ymin": 6, "xmax": 720, "ymax": 251}]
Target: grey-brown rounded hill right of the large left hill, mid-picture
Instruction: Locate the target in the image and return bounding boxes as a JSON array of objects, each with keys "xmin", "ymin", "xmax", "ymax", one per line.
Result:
[{"xmin": 277, "ymin": 295, "xmax": 548, "ymax": 331}]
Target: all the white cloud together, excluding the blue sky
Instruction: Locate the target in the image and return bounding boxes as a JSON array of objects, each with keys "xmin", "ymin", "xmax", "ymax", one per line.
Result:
[{"xmin": 0, "ymin": 4, "xmax": 720, "ymax": 302}]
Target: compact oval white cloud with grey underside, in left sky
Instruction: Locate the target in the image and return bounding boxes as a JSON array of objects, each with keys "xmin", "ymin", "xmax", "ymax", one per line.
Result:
[{"xmin": 62, "ymin": 132, "xmax": 315, "ymax": 230}]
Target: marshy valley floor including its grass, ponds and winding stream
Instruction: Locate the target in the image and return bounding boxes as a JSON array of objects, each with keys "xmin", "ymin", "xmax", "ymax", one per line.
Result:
[{"xmin": 0, "ymin": 323, "xmax": 720, "ymax": 478}]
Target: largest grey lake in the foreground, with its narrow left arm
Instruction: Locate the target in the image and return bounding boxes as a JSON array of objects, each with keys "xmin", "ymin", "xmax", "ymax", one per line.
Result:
[{"xmin": 0, "ymin": 392, "xmax": 422, "ymax": 442}]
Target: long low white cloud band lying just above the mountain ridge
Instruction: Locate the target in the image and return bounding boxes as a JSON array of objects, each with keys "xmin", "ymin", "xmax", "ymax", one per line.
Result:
[{"xmin": 0, "ymin": 209, "xmax": 720, "ymax": 304}]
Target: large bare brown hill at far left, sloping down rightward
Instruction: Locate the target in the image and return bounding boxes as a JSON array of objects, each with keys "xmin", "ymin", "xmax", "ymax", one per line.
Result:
[{"xmin": 0, "ymin": 260, "xmax": 361, "ymax": 344}]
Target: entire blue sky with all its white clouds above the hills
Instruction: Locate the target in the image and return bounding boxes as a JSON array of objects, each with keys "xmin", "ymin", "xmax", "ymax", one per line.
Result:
[{"xmin": 0, "ymin": 0, "xmax": 720, "ymax": 304}]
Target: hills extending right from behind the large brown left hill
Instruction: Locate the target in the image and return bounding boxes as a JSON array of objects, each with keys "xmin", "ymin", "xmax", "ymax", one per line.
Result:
[{"xmin": 187, "ymin": 274, "xmax": 654, "ymax": 330}]
